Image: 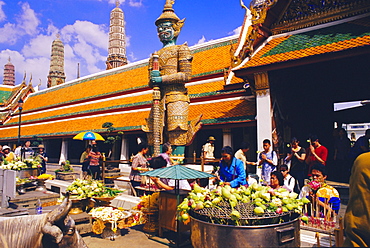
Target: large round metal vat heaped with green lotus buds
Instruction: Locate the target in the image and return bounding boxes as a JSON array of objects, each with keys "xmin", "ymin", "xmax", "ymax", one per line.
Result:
[{"xmin": 177, "ymin": 184, "xmax": 309, "ymax": 247}]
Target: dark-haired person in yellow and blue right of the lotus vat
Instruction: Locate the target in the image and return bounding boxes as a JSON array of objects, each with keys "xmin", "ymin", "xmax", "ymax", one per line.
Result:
[{"xmin": 299, "ymin": 163, "xmax": 340, "ymax": 213}]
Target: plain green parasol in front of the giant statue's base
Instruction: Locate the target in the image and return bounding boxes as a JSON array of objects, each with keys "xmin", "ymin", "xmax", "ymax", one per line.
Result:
[{"xmin": 140, "ymin": 164, "xmax": 214, "ymax": 180}]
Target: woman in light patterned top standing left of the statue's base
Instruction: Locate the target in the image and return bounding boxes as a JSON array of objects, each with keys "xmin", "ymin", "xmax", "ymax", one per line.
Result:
[{"xmin": 130, "ymin": 142, "xmax": 149, "ymax": 192}]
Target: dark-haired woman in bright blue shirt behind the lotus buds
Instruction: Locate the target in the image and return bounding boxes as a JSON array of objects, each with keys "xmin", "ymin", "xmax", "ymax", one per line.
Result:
[{"xmin": 218, "ymin": 146, "xmax": 247, "ymax": 188}]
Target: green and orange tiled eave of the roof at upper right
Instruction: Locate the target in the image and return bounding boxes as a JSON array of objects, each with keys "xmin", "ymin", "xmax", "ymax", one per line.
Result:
[{"xmin": 234, "ymin": 14, "xmax": 370, "ymax": 71}]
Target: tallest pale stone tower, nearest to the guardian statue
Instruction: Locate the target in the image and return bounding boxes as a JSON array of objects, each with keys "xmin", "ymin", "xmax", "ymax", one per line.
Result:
[{"xmin": 106, "ymin": 0, "xmax": 127, "ymax": 70}]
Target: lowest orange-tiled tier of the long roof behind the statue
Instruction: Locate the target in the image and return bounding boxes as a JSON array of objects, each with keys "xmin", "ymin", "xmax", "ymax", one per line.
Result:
[{"xmin": 0, "ymin": 99, "xmax": 255, "ymax": 139}]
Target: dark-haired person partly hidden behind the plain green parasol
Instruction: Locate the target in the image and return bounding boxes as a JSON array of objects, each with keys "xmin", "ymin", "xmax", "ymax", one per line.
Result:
[{"xmin": 150, "ymin": 156, "xmax": 191, "ymax": 190}]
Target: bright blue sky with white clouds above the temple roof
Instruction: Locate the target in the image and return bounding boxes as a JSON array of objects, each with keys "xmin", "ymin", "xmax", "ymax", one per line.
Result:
[{"xmin": 0, "ymin": 0, "xmax": 249, "ymax": 88}]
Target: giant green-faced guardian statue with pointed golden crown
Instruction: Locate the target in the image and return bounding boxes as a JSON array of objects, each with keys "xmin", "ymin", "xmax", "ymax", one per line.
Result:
[{"xmin": 142, "ymin": 0, "xmax": 201, "ymax": 155}]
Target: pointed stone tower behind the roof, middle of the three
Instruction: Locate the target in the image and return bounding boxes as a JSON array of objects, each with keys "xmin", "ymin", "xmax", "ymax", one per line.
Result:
[{"xmin": 48, "ymin": 34, "xmax": 66, "ymax": 87}]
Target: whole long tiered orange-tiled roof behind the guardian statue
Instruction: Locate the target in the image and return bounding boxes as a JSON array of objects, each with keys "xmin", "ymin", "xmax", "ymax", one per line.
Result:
[{"xmin": 0, "ymin": 37, "xmax": 251, "ymax": 139}]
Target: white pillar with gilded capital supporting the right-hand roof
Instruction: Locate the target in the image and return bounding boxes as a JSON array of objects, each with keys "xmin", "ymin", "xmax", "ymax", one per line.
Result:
[{"xmin": 254, "ymin": 72, "xmax": 272, "ymax": 178}]
